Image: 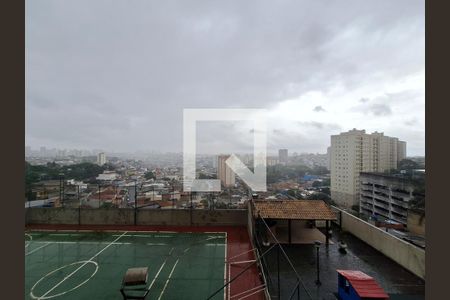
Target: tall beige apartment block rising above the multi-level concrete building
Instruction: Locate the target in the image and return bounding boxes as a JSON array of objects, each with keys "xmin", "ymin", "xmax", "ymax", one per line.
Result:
[{"xmin": 330, "ymin": 129, "xmax": 406, "ymax": 207}]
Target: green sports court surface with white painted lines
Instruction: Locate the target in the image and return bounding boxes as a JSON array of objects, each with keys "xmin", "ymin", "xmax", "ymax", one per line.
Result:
[{"xmin": 25, "ymin": 232, "xmax": 226, "ymax": 300}]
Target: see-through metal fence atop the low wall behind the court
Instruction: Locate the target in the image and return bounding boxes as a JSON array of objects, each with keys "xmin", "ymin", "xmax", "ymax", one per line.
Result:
[{"xmin": 25, "ymin": 181, "xmax": 250, "ymax": 210}]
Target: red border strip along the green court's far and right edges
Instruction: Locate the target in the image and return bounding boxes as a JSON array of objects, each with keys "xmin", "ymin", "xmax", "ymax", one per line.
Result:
[{"xmin": 26, "ymin": 224, "xmax": 265, "ymax": 300}]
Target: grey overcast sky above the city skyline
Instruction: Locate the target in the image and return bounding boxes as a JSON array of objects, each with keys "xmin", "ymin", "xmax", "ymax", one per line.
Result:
[{"xmin": 25, "ymin": 0, "xmax": 425, "ymax": 156}]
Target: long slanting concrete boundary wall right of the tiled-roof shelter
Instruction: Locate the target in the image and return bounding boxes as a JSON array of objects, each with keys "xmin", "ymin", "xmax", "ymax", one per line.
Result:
[{"xmin": 333, "ymin": 207, "xmax": 425, "ymax": 279}]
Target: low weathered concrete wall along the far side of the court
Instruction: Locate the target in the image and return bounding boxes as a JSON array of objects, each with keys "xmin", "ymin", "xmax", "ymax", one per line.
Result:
[{"xmin": 25, "ymin": 208, "xmax": 247, "ymax": 226}]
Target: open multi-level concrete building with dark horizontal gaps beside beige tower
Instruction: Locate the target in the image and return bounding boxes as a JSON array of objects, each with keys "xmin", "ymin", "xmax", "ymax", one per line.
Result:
[{"xmin": 359, "ymin": 172, "xmax": 415, "ymax": 226}]
